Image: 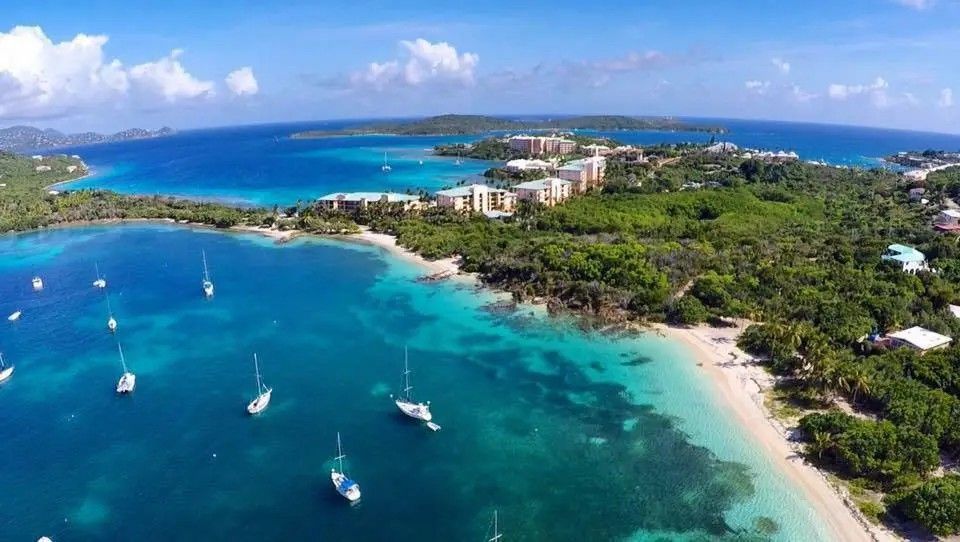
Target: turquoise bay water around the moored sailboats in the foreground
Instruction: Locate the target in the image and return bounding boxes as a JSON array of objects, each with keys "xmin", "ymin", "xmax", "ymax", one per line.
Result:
[{"xmin": 0, "ymin": 225, "xmax": 827, "ymax": 541}]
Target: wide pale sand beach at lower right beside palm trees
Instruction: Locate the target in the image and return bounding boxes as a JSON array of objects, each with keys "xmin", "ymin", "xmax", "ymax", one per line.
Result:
[{"xmin": 657, "ymin": 326, "xmax": 901, "ymax": 542}]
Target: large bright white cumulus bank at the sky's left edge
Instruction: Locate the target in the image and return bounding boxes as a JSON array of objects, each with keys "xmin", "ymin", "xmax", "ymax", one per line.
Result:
[{"xmin": 0, "ymin": 26, "xmax": 253, "ymax": 119}]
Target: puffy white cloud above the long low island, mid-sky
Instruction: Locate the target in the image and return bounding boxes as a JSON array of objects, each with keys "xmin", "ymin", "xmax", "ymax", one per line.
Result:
[{"xmin": 350, "ymin": 38, "xmax": 480, "ymax": 89}]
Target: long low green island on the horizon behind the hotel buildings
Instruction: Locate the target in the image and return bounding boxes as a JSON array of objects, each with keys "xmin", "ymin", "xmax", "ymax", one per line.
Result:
[{"xmin": 290, "ymin": 115, "xmax": 726, "ymax": 139}]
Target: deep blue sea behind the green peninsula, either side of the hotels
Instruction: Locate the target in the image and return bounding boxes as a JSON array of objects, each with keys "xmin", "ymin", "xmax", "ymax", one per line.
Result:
[{"xmin": 58, "ymin": 119, "xmax": 960, "ymax": 205}]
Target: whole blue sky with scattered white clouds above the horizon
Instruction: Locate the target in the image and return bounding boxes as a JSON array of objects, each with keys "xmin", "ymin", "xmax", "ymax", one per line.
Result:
[{"xmin": 0, "ymin": 0, "xmax": 960, "ymax": 133}]
